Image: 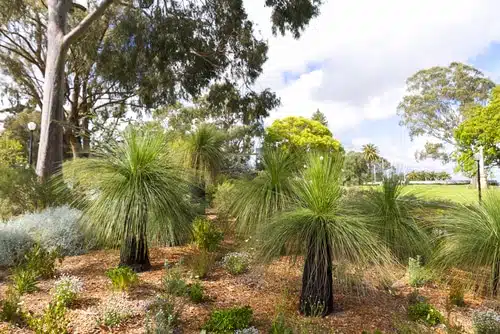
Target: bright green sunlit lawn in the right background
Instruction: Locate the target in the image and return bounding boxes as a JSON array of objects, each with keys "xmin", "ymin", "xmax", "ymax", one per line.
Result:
[{"xmin": 404, "ymin": 185, "xmax": 500, "ymax": 203}]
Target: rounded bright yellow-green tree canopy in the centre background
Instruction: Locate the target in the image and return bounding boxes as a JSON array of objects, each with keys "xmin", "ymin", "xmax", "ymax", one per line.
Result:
[{"xmin": 264, "ymin": 116, "xmax": 343, "ymax": 152}]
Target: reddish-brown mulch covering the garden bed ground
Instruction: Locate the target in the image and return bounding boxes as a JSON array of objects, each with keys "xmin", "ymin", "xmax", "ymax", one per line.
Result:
[{"xmin": 0, "ymin": 246, "xmax": 492, "ymax": 334}]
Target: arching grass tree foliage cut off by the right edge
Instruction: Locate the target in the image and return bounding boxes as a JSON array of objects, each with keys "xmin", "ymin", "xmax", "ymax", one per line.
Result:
[{"xmin": 434, "ymin": 191, "xmax": 500, "ymax": 296}]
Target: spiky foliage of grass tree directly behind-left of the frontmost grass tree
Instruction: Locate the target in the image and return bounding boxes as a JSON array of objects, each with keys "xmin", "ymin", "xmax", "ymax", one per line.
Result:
[{"xmin": 230, "ymin": 147, "xmax": 296, "ymax": 233}]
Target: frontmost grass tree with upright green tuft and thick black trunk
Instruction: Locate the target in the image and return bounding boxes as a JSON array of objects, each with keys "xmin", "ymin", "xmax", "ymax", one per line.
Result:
[{"xmin": 260, "ymin": 155, "xmax": 389, "ymax": 316}]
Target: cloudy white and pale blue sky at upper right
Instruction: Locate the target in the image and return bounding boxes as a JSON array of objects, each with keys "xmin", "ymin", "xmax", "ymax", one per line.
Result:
[{"xmin": 245, "ymin": 0, "xmax": 500, "ymax": 178}]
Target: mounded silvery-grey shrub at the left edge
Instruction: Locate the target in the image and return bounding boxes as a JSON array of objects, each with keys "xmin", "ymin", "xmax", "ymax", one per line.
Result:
[{"xmin": 0, "ymin": 206, "xmax": 85, "ymax": 266}]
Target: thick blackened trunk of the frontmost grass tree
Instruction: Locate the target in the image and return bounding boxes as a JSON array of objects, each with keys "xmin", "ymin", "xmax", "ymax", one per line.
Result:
[{"xmin": 300, "ymin": 232, "xmax": 333, "ymax": 316}]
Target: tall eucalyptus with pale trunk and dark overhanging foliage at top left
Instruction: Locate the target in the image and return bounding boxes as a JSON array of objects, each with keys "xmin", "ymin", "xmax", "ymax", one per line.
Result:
[{"xmin": 0, "ymin": 0, "xmax": 322, "ymax": 179}]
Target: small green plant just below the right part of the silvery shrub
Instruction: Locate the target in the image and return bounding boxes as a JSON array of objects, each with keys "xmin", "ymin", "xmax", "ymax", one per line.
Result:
[{"xmin": 21, "ymin": 243, "xmax": 63, "ymax": 278}]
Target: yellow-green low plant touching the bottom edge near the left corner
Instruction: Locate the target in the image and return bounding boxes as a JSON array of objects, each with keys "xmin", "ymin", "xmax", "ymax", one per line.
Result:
[{"xmin": 28, "ymin": 301, "xmax": 69, "ymax": 334}]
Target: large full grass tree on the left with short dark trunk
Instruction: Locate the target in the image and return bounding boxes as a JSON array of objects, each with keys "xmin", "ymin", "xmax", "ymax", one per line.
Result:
[{"xmin": 64, "ymin": 128, "xmax": 192, "ymax": 271}]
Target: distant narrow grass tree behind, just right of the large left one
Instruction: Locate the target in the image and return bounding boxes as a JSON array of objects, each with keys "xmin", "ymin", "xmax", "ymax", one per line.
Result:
[{"xmin": 186, "ymin": 124, "xmax": 225, "ymax": 198}]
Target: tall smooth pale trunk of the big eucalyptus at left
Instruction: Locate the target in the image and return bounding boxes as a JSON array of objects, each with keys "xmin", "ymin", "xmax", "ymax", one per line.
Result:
[{"xmin": 36, "ymin": 0, "xmax": 72, "ymax": 182}]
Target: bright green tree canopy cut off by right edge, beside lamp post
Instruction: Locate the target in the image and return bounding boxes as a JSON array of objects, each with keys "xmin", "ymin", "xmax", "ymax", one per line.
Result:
[{"xmin": 455, "ymin": 86, "xmax": 500, "ymax": 174}]
